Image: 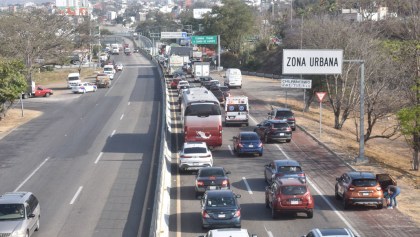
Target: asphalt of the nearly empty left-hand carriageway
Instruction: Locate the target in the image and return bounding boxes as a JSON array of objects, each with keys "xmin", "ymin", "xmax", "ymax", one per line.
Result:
[{"xmin": 0, "ymin": 46, "xmax": 162, "ymax": 237}]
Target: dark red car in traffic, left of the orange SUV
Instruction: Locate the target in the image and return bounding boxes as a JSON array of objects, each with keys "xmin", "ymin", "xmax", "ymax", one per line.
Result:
[{"xmin": 265, "ymin": 178, "xmax": 315, "ymax": 219}]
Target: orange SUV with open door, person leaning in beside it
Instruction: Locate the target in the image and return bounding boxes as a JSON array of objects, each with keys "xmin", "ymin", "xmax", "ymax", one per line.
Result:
[{"xmin": 335, "ymin": 171, "xmax": 396, "ymax": 209}]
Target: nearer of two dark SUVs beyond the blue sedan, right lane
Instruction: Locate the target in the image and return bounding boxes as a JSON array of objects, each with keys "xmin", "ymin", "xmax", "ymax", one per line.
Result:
[{"xmin": 254, "ymin": 120, "xmax": 292, "ymax": 143}]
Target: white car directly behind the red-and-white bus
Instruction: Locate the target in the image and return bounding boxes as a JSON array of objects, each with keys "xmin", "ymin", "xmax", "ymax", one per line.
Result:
[{"xmin": 179, "ymin": 142, "xmax": 213, "ymax": 171}]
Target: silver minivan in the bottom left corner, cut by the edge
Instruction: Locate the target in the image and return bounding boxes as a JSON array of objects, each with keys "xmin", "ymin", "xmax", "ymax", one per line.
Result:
[{"xmin": 0, "ymin": 192, "xmax": 41, "ymax": 237}]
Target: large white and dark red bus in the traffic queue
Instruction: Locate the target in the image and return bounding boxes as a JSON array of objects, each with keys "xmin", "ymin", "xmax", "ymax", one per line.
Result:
[{"xmin": 181, "ymin": 87, "xmax": 222, "ymax": 148}]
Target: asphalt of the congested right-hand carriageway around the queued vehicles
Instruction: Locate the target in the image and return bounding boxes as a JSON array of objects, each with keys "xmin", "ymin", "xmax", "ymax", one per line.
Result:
[{"xmin": 170, "ymin": 76, "xmax": 420, "ymax": 237}]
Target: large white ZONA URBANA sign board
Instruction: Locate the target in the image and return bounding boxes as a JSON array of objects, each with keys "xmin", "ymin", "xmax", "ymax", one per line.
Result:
[{"xmin": 283, "ymin": 49, "xmax": 343, "ymax": 75}]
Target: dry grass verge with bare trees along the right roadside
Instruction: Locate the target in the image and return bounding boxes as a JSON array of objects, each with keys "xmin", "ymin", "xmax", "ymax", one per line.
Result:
[{"xmin": 278, "ymin": 90, "xmax": 420, "ymax": 224}]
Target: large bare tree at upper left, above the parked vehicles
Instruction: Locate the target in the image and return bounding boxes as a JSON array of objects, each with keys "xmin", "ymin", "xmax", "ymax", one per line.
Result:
[{"xmin": 0, "ymin": 9, "xmax": 73, "ymax": 80}]
